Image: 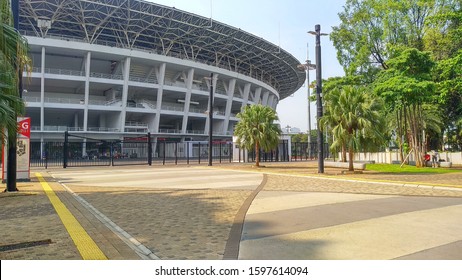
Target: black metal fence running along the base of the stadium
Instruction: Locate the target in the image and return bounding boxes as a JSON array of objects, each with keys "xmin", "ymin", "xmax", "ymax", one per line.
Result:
[{"xmin": 30, "ymin": 133, "xmax": 330, "ymax": 168}]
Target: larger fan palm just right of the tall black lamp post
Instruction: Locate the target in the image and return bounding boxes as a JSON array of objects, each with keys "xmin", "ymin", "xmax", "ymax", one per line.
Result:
[{"xmin": 320, "ymin": 86, "xmax": 383, "ymax": 171}]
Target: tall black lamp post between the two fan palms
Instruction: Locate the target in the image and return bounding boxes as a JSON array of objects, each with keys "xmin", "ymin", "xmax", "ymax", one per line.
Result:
[{"xmin": 308, "ymin": 24, "xmax": 327, "ymax": 173}]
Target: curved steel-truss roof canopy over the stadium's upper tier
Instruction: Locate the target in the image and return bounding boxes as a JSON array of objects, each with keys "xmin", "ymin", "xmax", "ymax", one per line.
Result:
[{"xmin": 19, "ymin": 0, "xmax": 305, "ymax": 99}]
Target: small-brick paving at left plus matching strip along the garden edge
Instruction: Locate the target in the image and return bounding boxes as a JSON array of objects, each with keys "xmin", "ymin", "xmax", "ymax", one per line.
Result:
[{"xmin": 0, "ymin": 162, "xmax": 462, "ymax": 260}]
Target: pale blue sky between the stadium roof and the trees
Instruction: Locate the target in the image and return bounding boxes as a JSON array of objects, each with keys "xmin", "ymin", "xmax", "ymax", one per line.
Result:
[{"xmin": 149, "ymin": 0, "xmax": 346, "ymax": 132}]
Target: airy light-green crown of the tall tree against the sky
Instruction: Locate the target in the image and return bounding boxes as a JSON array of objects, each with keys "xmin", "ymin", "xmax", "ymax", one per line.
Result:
[{"xmin": 330, "ymin": 0, "xmax": 438, "ymax": 76}]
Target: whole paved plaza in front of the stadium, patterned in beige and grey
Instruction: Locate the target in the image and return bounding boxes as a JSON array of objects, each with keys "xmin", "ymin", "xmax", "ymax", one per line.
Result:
[{"xmin": 0, "ymin": 162, "xmax": 462, "ymax": 260}]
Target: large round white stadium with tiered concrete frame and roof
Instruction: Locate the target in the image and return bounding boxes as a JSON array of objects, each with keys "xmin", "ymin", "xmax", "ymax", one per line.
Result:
[{"xmin": 19, "ymin": 0, "xmax": 305, "ymax": 142}]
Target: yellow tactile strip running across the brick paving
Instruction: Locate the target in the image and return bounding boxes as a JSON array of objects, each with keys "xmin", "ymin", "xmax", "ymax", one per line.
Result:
[{"xmin": 35, "ymin": 173, "xmax": 107, "ymax": 260}]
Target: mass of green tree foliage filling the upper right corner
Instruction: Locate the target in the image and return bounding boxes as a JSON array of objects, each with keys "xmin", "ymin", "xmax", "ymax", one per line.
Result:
[{"xmin": 332, "ymin": 0, "xmax": 462, "ymax": 153}]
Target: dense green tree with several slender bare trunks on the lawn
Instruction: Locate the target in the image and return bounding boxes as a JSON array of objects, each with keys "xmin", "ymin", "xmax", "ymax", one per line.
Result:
[{"xmin": 375, "ymin": 48, "xmax": 435, "ymax": 167}]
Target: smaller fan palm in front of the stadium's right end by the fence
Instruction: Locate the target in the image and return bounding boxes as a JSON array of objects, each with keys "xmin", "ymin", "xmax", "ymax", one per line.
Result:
[{"xmin": 234, "ymin": 104, "xmax": 281, "ymax": 166}]
